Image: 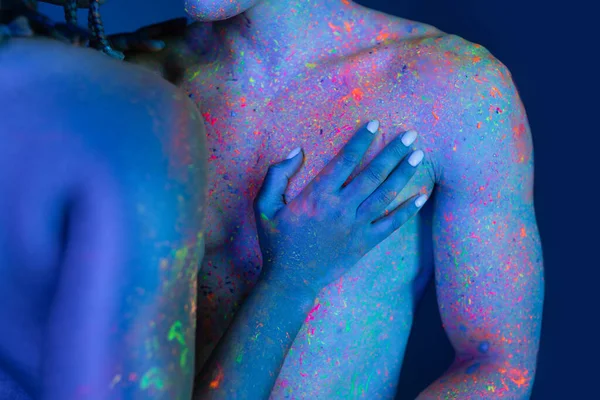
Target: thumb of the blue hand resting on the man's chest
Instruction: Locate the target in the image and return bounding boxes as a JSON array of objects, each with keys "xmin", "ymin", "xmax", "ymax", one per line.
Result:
[{"xmin": 254, "ymin": 147, "xmax": 303, "ymax": 219}]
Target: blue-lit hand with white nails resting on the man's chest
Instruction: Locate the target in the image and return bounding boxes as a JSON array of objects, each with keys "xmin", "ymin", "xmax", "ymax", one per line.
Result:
[{"xmin": 254, "ymin": 121, "xmax": 427, "ymax": 295}]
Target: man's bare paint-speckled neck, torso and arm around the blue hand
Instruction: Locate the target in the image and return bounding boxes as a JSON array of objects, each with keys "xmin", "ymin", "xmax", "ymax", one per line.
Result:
[{"xmin": 112, "ymin": 0, "xmax": 543, "ymax": 399}]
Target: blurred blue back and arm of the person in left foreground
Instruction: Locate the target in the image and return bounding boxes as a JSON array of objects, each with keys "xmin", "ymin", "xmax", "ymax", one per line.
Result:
[{"xmin": 0, "ymin": 38, "xmax": 206, "ymax": 400}]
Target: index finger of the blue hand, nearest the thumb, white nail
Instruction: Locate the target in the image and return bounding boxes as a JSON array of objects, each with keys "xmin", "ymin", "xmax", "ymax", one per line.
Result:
[{"xmin": 315, "ymin": 120, "xmax": 379, "ymax": 191}]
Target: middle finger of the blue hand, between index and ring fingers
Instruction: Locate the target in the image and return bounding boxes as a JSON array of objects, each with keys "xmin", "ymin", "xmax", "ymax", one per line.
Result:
[{"xmin": 342, "ymin": 130, "xmax": 417, "ymax": 204}]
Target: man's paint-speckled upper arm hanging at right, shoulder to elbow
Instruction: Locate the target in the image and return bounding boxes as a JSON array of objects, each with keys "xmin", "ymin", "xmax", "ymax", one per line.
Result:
[{"xmin": 433, "ymin": 42, "xmax": 543, "ymax": 395}]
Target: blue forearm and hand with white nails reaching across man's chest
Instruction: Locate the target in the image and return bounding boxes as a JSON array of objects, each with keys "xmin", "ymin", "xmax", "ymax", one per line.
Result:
[{"xmin": 195, "ymin": 121, "xmax": 426, "ymax": 400}]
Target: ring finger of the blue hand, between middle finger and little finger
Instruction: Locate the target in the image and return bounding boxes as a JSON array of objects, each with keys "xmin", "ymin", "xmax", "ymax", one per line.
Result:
[{"xmin": 356, "ymin": 150, "xmax": 424, "ymax": 221}]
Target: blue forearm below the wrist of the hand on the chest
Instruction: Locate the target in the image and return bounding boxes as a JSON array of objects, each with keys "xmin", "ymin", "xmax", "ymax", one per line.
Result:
[{"xmin": 194, "ymin": 282, "xmax": 314, "ymax": 400}]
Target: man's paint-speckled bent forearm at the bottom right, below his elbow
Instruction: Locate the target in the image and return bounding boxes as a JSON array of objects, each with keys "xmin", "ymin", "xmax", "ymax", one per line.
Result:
[{"xmin": 417, "ymin": 358, "xmax": 533, "ymax": 400}]
